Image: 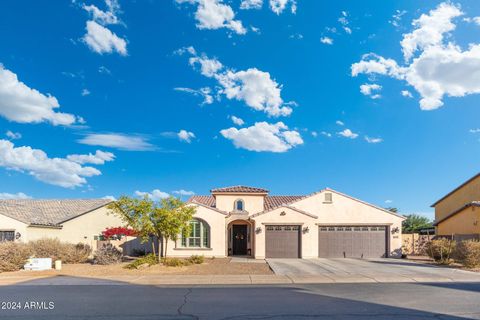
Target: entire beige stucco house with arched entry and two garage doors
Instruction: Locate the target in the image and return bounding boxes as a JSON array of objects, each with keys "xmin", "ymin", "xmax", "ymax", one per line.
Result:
[{"xmin": 168, "ymin": 186, "xmax": 405, "ymax": 259}]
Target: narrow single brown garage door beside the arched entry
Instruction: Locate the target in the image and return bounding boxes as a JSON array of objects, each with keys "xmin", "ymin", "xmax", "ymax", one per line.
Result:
[{"xmin": 265, "ymin": 225, "xmax": 300, "ymax": 258}]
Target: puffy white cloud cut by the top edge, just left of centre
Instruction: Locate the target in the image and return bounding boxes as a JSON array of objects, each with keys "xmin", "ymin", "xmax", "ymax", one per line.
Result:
[{"xmin": 176, "ymin": 0, "xmax": 247, "ymax": 35}]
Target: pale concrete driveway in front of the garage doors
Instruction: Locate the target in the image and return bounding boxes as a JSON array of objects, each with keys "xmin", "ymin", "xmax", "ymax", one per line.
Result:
[{"xmin": 267, "ymin": 258, "xmax": 480, "ymax": 282}]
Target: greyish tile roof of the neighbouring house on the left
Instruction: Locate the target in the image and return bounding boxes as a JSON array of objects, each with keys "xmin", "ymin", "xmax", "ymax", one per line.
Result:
[{"xmin": 0, "ymin": 199, "xmax": 112, "ymax": 226}]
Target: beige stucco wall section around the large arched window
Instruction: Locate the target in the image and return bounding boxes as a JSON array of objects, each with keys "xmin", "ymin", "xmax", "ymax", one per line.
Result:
[{"xmin": 167, "ymin": 205, "xmax": 226, "ymax": 257}]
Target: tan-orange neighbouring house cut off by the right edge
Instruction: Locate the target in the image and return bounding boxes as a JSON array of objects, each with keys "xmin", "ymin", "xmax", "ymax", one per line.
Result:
[{"xmin": 432, "ymin": 174, "xmax": 480, "ymax": 239}]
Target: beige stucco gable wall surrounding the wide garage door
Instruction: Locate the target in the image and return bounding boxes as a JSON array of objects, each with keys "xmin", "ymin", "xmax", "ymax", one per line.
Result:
[{"xmin": 292, "ymin": 191, "xmax": 403, "ymax": 257}]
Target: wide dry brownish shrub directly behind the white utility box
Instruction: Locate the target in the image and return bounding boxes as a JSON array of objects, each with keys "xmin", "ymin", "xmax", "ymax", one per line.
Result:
[{"xmin": 28, "ymin": 238, "xmax": 92, "ymax": 264}]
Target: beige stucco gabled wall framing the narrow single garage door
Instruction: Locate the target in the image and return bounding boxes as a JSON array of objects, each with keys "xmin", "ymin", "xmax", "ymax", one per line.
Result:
[{"xmin": 253, "ymin": 207, "xmax": 318, "ymax": 259}]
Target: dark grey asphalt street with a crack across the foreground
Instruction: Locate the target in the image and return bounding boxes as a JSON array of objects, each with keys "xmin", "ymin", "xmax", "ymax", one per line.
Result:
[{"xmin": 0, "ymin": 279, "xmax": 480, "ymax": 320}]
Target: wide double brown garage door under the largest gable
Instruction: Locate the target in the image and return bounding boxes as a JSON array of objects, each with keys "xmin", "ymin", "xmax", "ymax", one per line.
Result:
[{"xmin": 318, "ymin": 226, "xmax": 387, "ymax": 258}]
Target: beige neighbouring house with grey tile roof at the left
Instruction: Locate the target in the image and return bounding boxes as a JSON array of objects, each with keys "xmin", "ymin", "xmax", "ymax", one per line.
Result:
[{"xmin": 0, "ymin": 199, "xmax": 124, "ymax": 247}]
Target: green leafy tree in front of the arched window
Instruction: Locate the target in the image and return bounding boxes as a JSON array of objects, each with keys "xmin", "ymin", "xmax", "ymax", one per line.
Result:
[{"xmin": 109, "ymin": 196, "xmax": 195, "ymax": 258}]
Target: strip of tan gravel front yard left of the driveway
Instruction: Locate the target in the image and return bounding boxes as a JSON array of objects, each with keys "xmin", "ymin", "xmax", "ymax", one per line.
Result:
[{"xmin": 0, "ymin": 258, "xmax": 273, "ymax": 277}]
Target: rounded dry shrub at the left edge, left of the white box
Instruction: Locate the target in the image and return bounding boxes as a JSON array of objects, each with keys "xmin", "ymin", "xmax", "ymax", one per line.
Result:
[{"xmin": 0, "ymin": 241, "xmax": 32, "ymax": 272}]
